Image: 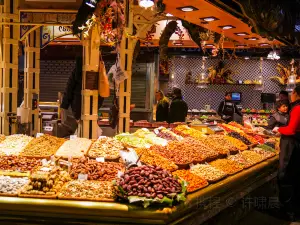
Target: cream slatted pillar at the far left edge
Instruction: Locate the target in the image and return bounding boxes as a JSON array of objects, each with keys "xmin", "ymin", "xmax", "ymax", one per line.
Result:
[{"xmin": 0, "ymin": 0, "xmax": 20, "ymax": 135}]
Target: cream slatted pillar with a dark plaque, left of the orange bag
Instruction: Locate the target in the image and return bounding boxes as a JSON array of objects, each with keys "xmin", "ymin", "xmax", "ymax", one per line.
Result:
[{"xmin": 81, "ymin": 27, "xmax": 100, "ymax": 139}]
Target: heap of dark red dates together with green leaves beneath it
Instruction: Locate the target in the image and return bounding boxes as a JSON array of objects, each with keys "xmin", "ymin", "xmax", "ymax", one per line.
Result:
[{"xmin": 116, "ymin": 166, "xmax": 185, "ymax": 207}]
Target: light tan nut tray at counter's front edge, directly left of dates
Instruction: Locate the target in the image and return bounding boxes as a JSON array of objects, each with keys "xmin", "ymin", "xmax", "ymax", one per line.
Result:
[{"xmin": 58, "ymin": 180, "xmax": 116, "ymax": 201}]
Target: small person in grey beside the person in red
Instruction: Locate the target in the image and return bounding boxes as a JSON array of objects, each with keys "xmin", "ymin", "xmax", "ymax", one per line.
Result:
[{"xmin": 267, "ymin": 100, "xmax": 289, "ymax": 130}]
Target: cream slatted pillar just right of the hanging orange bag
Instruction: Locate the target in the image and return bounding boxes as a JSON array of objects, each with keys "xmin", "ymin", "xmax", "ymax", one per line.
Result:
[{"xmin": 118, "ymin": 0, "xmax": 136, "ymax": 133}]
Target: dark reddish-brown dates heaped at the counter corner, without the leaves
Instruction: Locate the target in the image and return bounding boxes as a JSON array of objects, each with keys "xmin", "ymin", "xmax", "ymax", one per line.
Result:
[{"xmin": 117, "ymin": 166, "xmax": 182, "ymax": 199}]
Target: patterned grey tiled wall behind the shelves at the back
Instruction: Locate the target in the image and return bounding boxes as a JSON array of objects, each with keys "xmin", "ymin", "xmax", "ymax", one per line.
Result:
[{"xmin": 169, "ymin": 58, "xmax": 289, "ymax": 110}]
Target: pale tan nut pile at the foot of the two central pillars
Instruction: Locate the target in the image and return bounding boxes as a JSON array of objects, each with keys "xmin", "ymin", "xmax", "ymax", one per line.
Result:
[{"xmin": 88, "ymin": 137, "xmax": 124, "ymax": 159}]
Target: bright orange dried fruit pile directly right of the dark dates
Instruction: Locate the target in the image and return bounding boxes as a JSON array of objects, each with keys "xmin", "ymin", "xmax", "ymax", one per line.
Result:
[{"xmin": 172, "ymin": 170, "xmax": 208, "ymax": 192}]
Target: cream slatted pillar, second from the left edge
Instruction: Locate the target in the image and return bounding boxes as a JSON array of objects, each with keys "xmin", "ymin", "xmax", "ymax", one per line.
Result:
[{"xmin": 24, "ymin": 29, "xmax": 40, "ymax": 135}]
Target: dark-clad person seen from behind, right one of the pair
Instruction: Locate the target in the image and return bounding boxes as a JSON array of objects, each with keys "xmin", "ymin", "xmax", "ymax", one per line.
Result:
[{"xmin": 169, "ymin": 88, "xmax": 188, "ymax": 123}]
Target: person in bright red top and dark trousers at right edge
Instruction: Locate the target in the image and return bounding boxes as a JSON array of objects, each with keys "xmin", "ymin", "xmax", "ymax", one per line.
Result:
[{"xmin": 278, "ymin": 86, "xmax": 300, "ymax": 219}]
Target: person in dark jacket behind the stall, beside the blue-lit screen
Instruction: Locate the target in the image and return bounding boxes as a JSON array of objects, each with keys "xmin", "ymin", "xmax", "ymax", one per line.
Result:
[{"xmin": 218, "ymin": 92, "xmax": 243, "ymax": 123}]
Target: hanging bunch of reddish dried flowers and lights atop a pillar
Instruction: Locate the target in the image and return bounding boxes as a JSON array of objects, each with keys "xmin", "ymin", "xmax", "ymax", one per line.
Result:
[{"xmin": 78, "ymin": 0, "xmax": 125, "ymax": 46}]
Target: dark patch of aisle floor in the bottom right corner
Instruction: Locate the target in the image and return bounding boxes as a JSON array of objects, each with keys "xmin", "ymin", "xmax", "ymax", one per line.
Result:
[{"xmin": 238, "ymin": 210, "xmax": 300, "ymax": 225}]
